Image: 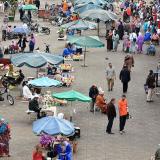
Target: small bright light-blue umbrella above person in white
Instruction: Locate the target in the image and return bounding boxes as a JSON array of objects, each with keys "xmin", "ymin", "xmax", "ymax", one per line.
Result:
[{"xmin": 28, "ymin": 77, "xmax": 62, "ymax": 87}]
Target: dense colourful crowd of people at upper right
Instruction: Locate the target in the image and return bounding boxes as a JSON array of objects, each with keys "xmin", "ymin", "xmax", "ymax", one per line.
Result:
[{"xmin": 106, "ymin": 0, "xmax": 160, "ymax": 55}]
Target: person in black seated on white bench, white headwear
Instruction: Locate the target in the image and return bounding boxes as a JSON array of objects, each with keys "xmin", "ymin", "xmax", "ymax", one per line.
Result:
[{"xmin": 28, "ymin": 95, "xmax": 41, "ymax": 119}]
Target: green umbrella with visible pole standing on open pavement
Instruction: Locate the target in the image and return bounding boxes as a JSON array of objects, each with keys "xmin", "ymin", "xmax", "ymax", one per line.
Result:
[{"xmin": 67, "ymin": 36, "xmax": 104, "ymax": 67}]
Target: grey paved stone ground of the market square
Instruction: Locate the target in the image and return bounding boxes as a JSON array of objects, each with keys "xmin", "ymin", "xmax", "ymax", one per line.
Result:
[{"xmin": 0, "ymin": 0, "xmax": 160, "ymax": 160}]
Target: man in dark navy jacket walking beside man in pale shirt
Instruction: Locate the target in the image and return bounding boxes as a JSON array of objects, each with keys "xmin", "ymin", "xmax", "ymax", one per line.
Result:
[{"xmin": 119, "ymin": 66, "xmax": 131, "ymax": 93}]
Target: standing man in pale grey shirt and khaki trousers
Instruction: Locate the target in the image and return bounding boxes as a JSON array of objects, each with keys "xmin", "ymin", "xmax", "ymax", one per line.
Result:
[{"xmin": 106, "ymin": 63, "xmax": 116, "ymax": 91}]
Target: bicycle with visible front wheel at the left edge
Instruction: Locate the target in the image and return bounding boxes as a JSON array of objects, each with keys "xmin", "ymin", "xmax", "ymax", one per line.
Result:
[{"xmin": 0, "ymin": 88, "xmax": 14, "ymax": 105}]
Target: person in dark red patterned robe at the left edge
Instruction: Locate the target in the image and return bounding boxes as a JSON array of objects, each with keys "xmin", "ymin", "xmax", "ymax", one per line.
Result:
[{"xmin": 0, "ymin": 119, "xmax": 10, "ymax": 157}]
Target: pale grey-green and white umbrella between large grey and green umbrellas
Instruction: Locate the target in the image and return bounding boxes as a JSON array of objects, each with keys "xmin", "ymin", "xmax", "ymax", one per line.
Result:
[{"xmin": 61, "ymin": 19, "xmax": 97, "ymax": 30}]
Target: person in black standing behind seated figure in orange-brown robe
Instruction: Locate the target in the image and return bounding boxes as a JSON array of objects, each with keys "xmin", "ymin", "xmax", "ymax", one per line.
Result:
[{"xmin": 89, "ymin": 84, "xmax": 99, "ymax": 112}]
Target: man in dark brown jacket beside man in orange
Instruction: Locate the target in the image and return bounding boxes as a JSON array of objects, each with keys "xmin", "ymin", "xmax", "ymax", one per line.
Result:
[{"xmin": 106, "ymin": 98, "xmax": 116, "ymax": 134}]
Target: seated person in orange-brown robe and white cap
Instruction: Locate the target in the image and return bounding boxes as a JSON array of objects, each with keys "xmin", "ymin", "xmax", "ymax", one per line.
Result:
[{"xmin": 96, "ymin": 90, "xmax": 107, "ymax": 114}]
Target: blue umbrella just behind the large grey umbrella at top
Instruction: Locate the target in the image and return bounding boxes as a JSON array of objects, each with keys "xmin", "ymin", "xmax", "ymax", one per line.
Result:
[{"xmin": 74, "ymin": 3, "xmax": 101, "ymax": 14}]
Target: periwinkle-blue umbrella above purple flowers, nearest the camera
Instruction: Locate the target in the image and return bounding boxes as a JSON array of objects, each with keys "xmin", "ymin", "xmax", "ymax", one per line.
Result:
[{"xmin": 33, "ymin": 116, "xmax": 75, "ymax": 136}]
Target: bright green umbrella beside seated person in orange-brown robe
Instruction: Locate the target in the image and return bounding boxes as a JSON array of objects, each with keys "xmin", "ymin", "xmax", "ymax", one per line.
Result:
[{"xmin": 52, "ymin": 90, "xmax": 91, "ymax": 102}]
